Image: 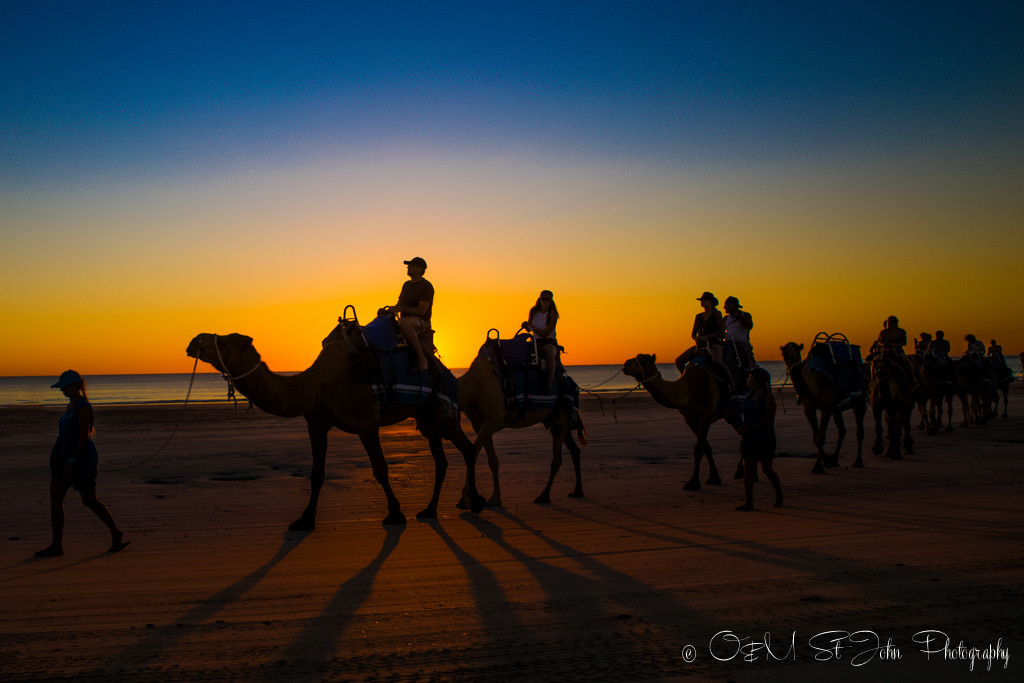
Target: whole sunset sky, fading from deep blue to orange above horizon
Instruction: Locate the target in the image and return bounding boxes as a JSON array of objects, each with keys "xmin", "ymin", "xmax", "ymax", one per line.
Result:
[{"xmin": 0, "ymin": 0, "xmax": 1024, "ymax": 376}]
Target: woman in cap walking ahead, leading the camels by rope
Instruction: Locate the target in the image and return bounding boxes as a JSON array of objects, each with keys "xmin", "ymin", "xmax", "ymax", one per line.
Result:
[{"xmin": 36, "ymin": 370, "xmax": 131, "ymax": 557}]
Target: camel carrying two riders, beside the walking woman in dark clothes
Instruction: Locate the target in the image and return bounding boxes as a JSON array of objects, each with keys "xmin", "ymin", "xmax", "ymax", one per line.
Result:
[{"xmin": 623, "ymin": 353, "xmax": 729, "ymax": 490}]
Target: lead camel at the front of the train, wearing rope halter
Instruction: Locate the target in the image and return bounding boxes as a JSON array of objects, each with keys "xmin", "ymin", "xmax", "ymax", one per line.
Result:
[{"xmin": 185, "ymin": 334, "xmax": 485, "ymax": 530}]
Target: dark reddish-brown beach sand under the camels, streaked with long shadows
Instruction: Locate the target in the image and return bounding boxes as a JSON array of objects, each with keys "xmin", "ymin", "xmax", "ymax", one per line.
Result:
[{"xmin": 0, "ymin": 382, "xmax": 1024, "ymax": 682}]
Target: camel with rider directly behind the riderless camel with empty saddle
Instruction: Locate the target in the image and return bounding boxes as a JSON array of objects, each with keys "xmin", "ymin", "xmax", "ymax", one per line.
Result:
[{"xmin": 868, "ymin": 355, "xmax": 918, "ymax": 460}]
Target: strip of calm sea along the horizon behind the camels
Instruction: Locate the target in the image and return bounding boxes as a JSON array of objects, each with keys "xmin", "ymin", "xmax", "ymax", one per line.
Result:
[{"xmin": 6, "ymin": 357, "xmax": 1021, "ymax": 407}]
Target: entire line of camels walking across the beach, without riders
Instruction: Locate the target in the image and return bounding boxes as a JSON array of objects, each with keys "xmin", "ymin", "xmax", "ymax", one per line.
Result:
[{"xmin": 186, "ymin": 308, "xmax": 1013, "ymax": 529}]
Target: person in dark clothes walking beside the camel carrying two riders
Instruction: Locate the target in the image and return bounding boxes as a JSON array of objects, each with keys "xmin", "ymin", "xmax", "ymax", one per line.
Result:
[{"xmin": 736, "ymin": 366, "xmax": 782, "ymax": 510}]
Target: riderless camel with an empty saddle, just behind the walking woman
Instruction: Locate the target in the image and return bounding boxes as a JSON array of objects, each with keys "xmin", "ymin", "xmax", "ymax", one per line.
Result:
[{"xmin": 780, "ymin": 335, "xmax": 867, "ymax": 474}]
